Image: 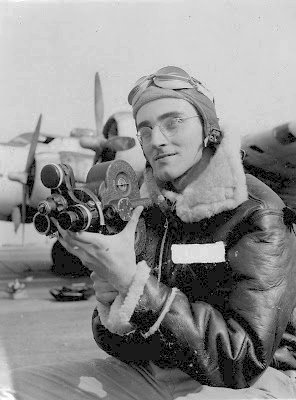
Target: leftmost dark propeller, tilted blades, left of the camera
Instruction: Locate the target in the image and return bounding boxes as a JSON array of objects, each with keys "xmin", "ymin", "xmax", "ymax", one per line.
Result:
[{"xmin": 8, "ymin": 114, "xmax": 42, "ymax": 244}]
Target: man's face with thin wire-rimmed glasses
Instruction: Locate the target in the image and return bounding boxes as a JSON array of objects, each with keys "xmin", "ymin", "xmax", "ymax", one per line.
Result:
[{"xmin": 136, "ymin": 98, "xmax": 203, "ymax": 182}]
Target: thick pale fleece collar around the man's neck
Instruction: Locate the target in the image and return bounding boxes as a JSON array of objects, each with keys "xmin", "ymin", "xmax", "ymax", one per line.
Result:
[{"xmin": 141, "ymin": 134, "xmax": 248, "ymax": 223}]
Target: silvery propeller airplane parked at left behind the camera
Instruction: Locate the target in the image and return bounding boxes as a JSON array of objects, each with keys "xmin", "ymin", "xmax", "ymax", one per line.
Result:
[{"xmin": 0, "ymin": 73, "xmax": 145, "ymax": 271}]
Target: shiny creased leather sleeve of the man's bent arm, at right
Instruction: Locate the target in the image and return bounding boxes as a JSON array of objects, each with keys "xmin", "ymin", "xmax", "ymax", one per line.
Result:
[{"xmin": 94, "ymin": 210, "xmax": 296, "ymax": 389}]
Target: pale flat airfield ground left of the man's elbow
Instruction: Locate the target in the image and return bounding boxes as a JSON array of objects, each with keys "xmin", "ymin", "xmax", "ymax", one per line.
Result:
[{"xmin": 0, "ymin": 273, "xmax": 106, "ymax": 383}]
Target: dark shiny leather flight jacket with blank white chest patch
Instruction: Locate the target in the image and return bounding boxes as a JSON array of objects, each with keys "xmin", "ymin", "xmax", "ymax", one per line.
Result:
[{"xmin": 93, "ymin": 175, "xmax": 296, "ymax": 389}]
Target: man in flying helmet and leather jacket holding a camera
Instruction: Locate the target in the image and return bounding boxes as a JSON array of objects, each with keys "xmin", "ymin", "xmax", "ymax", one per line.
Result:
[{"xmin": 11, "ymin": 67, "xmax": 296, "ymax": 400}]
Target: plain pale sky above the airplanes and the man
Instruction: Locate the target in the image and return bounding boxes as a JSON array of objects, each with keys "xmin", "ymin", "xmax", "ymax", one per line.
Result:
[{"xmin": 0, "ymin": 0, "xmax": 296, "ymax": 141}]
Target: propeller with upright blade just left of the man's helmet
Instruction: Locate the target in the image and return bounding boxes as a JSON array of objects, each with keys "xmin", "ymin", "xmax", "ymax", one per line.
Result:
[{"xmin": 80, "ymin": 72, "xmax": 136, "ymax": 160}]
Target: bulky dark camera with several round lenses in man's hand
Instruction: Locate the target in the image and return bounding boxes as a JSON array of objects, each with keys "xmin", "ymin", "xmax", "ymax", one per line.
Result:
[{"xmin": 33, "ymin": 160, "xmax": 151, "ymax": 255}]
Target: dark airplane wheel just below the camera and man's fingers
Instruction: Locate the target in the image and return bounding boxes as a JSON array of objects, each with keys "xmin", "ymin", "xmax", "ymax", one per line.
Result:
[{"xmin": 51, "ymin": 241, "xmax": 90, "ymax": 276}]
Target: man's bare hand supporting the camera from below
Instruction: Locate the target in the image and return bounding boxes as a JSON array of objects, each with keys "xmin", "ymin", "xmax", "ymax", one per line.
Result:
[{"xmin": 54, "ymin": 206, "xmax": 143, "ymax": 295}]
